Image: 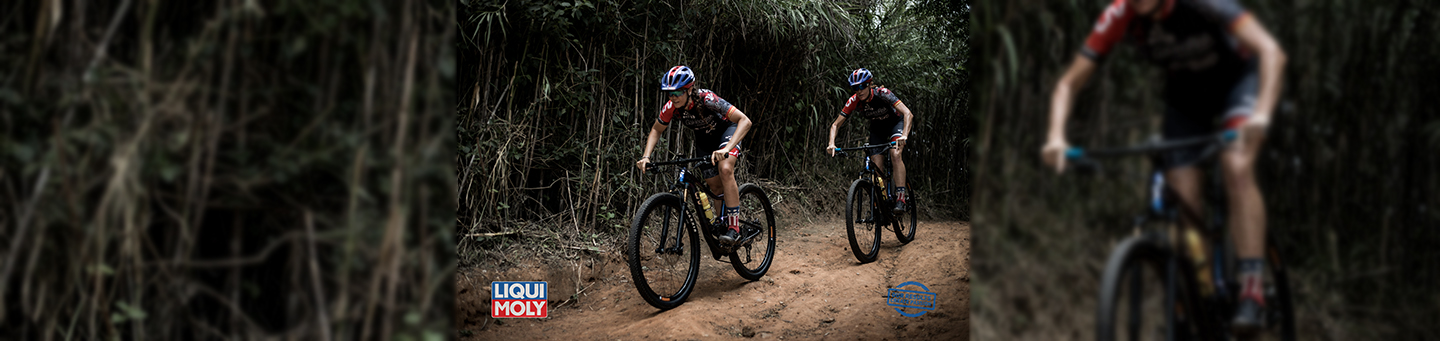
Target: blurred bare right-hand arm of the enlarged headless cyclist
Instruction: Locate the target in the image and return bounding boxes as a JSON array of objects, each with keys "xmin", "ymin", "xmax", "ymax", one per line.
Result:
[{"xmin": 1234, "ymin": 16, "xmax": 1286, "ymax": 129}]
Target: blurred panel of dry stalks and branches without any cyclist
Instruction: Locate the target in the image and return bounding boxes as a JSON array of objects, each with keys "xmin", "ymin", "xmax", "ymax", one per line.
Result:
[{"xmin": 0, "ymin": 0, "xmax": 456, "ymax": 340}]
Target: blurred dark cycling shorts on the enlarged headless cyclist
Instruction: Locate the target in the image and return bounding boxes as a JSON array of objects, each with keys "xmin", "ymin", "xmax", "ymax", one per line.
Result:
[{"xmin": 1161, "ymin": 62, "xmax": 1260, "ymax": 170}]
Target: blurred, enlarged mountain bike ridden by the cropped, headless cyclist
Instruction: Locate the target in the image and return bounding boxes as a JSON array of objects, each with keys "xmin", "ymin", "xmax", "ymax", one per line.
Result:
[{"xmin": 1066, "ymin": 131, "xmax": 1295, "ymax": 341}]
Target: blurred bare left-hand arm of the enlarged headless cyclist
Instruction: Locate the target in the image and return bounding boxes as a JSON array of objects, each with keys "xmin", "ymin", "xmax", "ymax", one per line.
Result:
[{"xmin": 1040, "ymin": 53, "xmax": 1096, "ymax": 173}]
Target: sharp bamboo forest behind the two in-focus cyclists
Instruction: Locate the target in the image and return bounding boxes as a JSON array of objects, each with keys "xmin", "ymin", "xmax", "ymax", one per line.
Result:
[{"xmin": 455, "ymin": 0, "xmax": 973, "ymax": 266}]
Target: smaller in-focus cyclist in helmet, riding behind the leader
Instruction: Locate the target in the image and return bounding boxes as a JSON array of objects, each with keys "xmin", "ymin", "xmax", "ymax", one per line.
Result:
[{"xmin": 825, "ymin": 68, "xmax": 914, "ymax": 213}]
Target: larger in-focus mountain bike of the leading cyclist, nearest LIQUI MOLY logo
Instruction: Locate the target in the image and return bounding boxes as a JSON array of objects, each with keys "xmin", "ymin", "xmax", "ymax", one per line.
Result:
[{"xmin": 625, "ymin": 157, "xmax": 775, "ymax": 309}]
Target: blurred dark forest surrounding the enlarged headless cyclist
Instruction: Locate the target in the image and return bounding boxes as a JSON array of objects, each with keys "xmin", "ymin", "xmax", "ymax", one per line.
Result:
[{"xmin": 972, "ymin": 0, "xmax": 1440, "ymax": 340}]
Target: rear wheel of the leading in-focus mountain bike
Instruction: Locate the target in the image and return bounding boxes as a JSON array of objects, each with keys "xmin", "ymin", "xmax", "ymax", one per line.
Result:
[{"xmin": 730, "ymin": 184, "xmax": 775, "ymax": 281}]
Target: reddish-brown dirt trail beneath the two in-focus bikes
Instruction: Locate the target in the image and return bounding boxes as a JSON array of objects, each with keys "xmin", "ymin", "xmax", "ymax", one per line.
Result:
[{"xmin": 455, "ymin": 220, "xmax": 971, "ymax": 340}]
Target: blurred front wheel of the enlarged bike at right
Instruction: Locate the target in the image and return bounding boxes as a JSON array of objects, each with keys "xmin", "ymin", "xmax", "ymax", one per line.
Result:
[{"xmin": 1096, "ymin": 235, "xmax": 1178, "ymax": 341}]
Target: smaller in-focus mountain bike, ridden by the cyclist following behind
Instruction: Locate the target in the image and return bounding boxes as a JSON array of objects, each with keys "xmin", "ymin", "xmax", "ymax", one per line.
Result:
[{"xmin": 835, "ymin": 142, "xmax": 919, "ymax": 263}]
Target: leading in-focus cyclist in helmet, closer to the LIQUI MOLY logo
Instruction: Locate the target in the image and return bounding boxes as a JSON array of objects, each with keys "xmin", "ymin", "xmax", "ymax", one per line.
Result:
[{"xmin": 635, "ymin": 65, "xmax": 752, "ymax": 243}]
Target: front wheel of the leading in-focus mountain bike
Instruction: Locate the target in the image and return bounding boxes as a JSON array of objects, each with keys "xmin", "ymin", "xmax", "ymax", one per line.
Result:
[{"xmin": 625, "ymin": 193, "xmax": 700, "ymax": 309}]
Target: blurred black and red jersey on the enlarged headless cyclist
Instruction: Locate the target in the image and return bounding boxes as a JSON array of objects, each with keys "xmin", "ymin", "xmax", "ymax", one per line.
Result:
[{"xmin": 1080, "ymin": 0, "xmax": 1253, "ymax": 107}]
